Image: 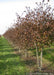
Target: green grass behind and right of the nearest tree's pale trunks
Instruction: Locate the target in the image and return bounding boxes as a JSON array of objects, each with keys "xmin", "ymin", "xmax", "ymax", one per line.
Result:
[{"xmin": 30, "ymin": 44, "xmax": 54, "ymax": 70}]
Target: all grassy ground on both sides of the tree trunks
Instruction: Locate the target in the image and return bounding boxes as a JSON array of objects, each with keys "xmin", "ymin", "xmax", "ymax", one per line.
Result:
[{"xmin": 0, "ymin": 37, "xmax": 54, "ymax": 75}]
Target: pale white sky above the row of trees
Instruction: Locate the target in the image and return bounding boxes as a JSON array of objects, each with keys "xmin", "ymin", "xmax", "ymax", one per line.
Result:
[{"xmin": 0, "ymin": 0, "xmax": 54, "ymax": 34}]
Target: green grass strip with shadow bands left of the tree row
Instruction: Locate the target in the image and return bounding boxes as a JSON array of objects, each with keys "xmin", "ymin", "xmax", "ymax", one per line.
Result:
[{"xmin": 0, "ymin": 37, "xmax": 28, "ymax": 75}]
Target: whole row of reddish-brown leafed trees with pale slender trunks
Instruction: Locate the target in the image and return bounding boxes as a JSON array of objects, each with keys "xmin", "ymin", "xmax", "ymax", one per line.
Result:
[{"xmin": 4, "ymin": 2, "xmax": 54, "ymax": 70}]
